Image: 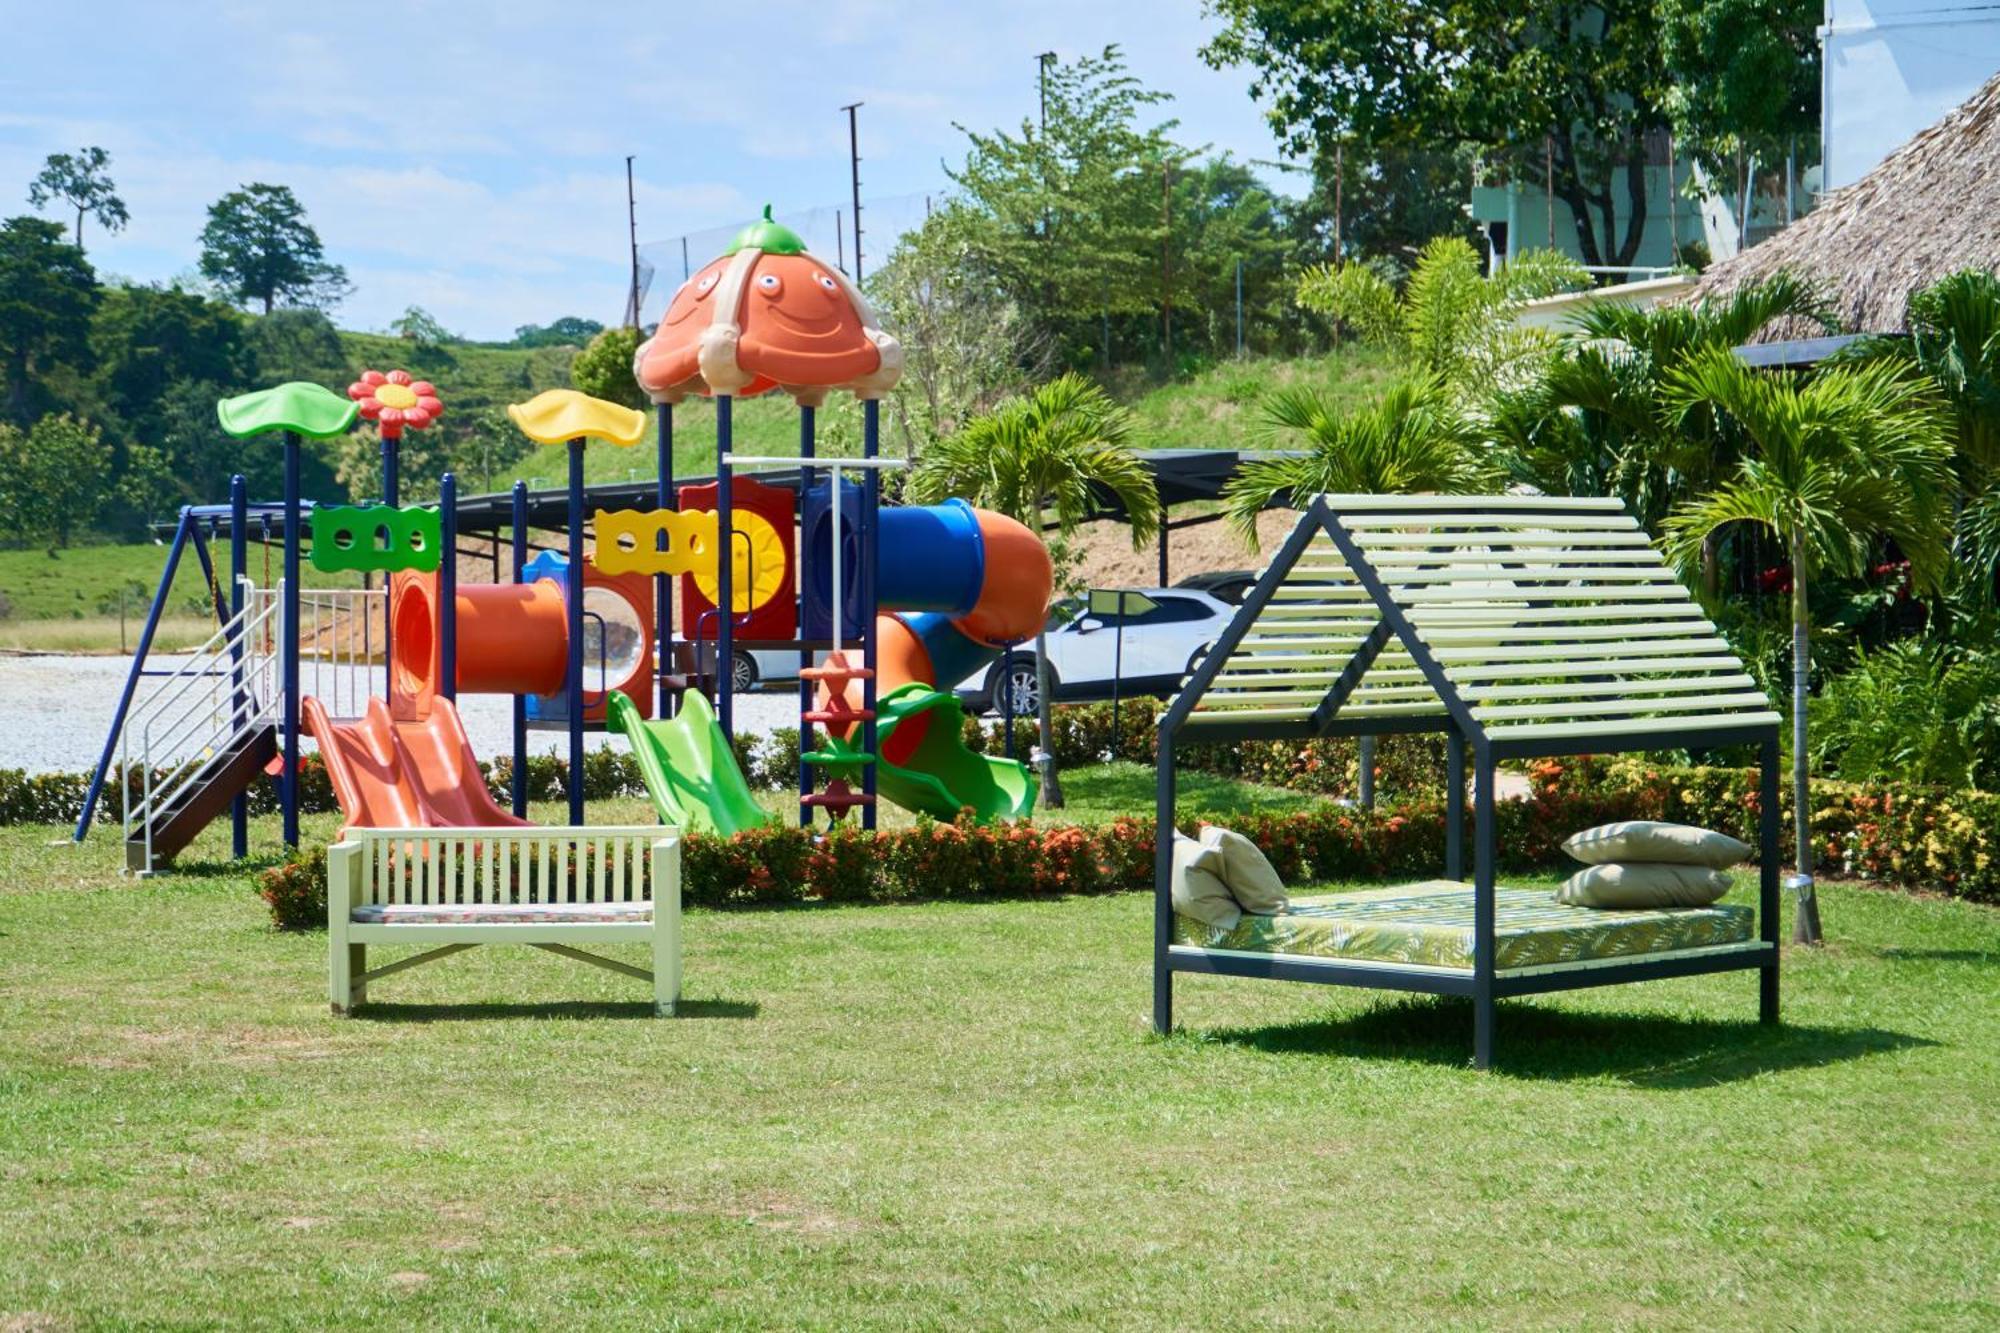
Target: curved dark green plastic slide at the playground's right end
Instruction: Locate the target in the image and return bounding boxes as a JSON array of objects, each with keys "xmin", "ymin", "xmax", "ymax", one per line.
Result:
[{"xmin": 812, "ymin": 685, "xmax": 1038, "ymax": 821}]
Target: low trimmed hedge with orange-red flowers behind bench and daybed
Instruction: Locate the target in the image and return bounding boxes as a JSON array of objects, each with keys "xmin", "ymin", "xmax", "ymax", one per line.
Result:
[{"xmin": 262, "ymin": 757, "xmax": 2000, "ymax": 929}]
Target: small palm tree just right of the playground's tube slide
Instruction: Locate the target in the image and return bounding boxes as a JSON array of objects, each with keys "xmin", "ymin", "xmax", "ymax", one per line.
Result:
[{"xmin": 908, "ymin": 372, "xmax": 1160, "ymax": 809}]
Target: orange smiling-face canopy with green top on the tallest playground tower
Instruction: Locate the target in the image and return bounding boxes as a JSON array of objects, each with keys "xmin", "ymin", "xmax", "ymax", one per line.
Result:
[{"xmin": 632, "ymin": 206, "xmax": 902, "ymax": 404}]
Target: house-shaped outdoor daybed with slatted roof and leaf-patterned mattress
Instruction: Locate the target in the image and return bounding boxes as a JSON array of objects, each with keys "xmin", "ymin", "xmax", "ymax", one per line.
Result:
[{"xmin": 1154, "ymin": 494, "xmax": 1778, "ymax": 1069}]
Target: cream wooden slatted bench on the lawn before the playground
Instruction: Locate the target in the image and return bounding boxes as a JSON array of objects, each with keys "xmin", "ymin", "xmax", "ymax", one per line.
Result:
[{"xmin": 326, "ymin": 827, "xmax": 680, "ymax": 1017}]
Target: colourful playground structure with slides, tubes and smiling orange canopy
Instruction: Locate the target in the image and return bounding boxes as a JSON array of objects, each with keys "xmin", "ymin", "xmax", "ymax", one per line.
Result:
[{"xmin": 76, "ymin": 210, "xmax": 1052, "ymax": 873}]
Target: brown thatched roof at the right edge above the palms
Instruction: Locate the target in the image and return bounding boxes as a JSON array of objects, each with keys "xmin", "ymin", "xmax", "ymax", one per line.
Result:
[{"xmin": 1686, "ymin": 74, "xmax": 2000, "ymax": 340}]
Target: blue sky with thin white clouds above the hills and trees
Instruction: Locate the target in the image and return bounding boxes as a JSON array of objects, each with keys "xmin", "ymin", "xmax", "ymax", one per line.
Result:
[{"xmin": 0, "ymin": 0, "xmax": 1276, "ymax": 338}]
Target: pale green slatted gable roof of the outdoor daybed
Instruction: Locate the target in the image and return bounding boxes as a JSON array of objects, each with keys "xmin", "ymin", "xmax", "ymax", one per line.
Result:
[{"xmin": 1168, "ymin": 494, "xmax": 1778, "ymax": 755}]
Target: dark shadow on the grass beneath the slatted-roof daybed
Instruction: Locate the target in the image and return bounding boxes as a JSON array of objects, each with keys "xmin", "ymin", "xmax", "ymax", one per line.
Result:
[{"xmin": 1196, "ymin": 997, "xmax": 1938, "ymax": 1089}]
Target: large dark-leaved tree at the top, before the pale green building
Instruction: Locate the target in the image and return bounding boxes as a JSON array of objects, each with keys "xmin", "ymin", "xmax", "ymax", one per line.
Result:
[{"xmin": 1202, "ymin": 0, "xmax": 1666, "ymax": 264}]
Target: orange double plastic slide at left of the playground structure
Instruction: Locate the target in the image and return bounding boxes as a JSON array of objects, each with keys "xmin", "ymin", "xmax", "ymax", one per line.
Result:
[{"xmin": 298, "ymin": 697, "xmax": 528, "ymax": 829}]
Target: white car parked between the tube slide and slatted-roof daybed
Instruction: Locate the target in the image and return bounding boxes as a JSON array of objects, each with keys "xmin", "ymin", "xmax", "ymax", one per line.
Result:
[{"xmin": 958, "ymin": 588, "xmax": 1236, "ymax": 717}]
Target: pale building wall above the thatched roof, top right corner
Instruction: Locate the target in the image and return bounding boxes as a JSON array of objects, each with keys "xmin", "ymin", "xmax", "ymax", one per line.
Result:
[{"xmin": 1820, "ymin": 0, "xmax": 2000, "ymax": 190}]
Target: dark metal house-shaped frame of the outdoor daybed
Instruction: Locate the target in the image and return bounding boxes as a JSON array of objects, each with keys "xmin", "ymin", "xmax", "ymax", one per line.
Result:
[{"xmin": 1152, "ymin": 496, "xmax": 1780, "ymax": 1069}]
